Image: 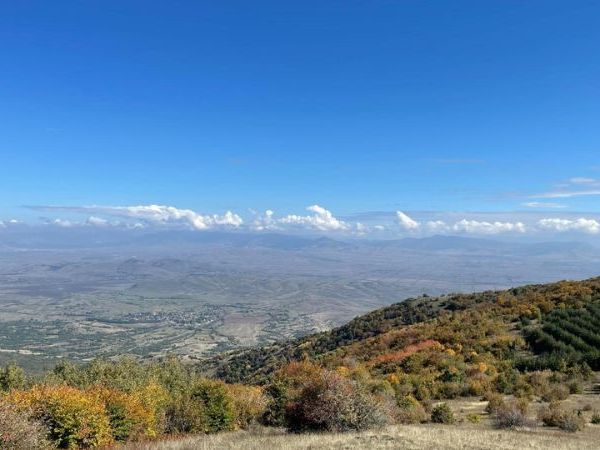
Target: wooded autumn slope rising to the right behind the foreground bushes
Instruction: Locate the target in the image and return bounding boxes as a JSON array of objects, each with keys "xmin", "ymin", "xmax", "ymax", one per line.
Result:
[{"xmin": 209, "ymin": 278, "xmax": 600, "ymax": 383}]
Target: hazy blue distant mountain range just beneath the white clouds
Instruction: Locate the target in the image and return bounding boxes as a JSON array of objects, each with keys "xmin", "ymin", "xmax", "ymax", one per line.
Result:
[{"xmin": 0, "ymin": 226, "xmax": 598, "ymax": 254}]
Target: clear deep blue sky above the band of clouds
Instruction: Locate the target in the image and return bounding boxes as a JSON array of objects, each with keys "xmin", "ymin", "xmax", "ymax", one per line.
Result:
[{"xmin": 0, "ymin": 0, "xmax": 600, "ymax": 236}]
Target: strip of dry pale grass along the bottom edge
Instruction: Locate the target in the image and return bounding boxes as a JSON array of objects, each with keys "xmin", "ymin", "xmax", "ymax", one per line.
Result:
[{"xmin": 123, "ymin": 424, "xmax": 600, "ymax": 450}]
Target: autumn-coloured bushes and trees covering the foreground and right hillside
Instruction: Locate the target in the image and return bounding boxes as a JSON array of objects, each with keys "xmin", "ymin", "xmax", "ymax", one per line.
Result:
[{"xmin": 0, "ymin": 279, "xmax": 600, "ymax": 448}]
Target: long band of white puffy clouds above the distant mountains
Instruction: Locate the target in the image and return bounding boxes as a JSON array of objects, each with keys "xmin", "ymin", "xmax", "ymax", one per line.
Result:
[{"xmin": 19, "ymin": 205, "xmax": 600, "ymax": 237}]
